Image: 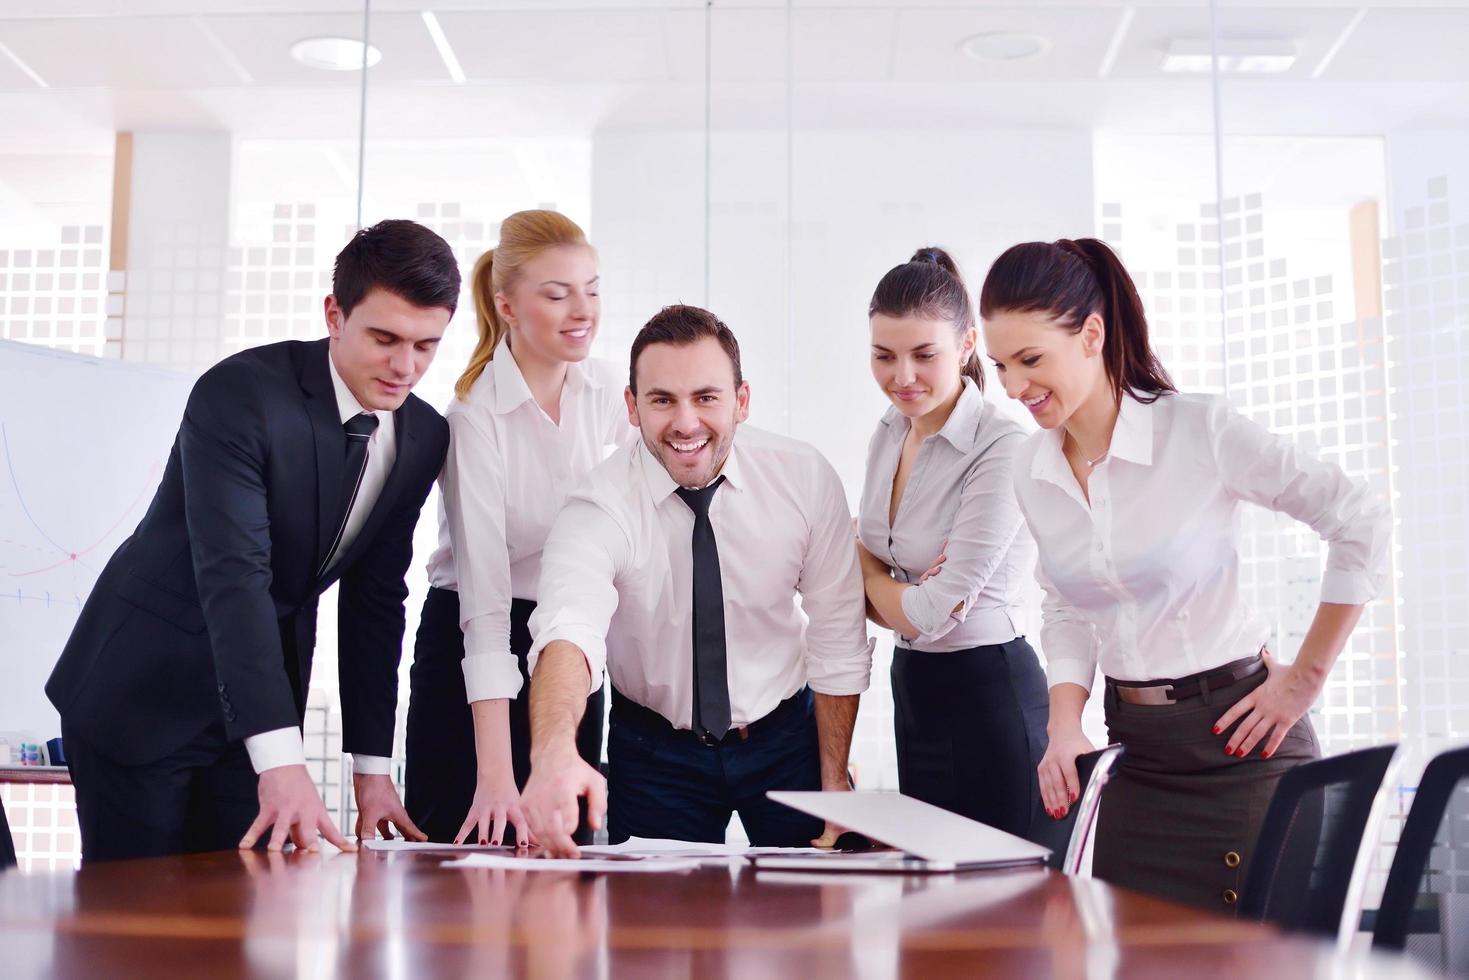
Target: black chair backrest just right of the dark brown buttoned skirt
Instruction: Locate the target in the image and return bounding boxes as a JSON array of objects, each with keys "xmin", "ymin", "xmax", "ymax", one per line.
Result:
[{"xmin": 1240, "ymin": 745, "xmax": 1397, "ymax": 939}]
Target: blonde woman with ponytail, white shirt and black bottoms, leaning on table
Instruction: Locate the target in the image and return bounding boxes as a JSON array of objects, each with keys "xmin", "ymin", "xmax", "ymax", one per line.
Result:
[{"xmin": 405, "ymin": 210, "xmax": 636, "ymax": 843}]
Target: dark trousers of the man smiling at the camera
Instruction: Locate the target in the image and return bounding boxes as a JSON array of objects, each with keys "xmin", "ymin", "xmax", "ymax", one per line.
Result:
[{"xmin": 607, "ymin": 688, "xmax": 824, "ymax": 846}]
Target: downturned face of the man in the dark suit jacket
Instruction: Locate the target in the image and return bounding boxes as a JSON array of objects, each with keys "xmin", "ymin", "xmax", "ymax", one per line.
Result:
[{"xmin": 326, "ymin": 288, "xmax": 451, "ymax": 411}]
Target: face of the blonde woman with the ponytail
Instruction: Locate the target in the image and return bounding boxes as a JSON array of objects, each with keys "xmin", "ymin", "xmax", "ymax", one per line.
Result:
[{"xmin": 495, "ymin": 245, "xmax": 602, "ymax": 363}]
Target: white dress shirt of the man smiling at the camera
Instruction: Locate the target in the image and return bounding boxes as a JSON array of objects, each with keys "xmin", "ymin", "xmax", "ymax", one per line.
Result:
[{"xmin": 530, "ymin": 425, "xmax": 873, "ymax": 729}]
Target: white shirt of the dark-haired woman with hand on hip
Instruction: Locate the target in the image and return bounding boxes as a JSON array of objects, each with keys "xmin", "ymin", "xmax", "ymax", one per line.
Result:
[{"xmin": 1015, "ymin": 395, "xmax": 1393, "ymax": 691}]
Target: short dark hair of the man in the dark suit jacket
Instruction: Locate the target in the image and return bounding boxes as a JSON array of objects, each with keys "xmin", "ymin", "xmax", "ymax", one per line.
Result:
[{"xmin": 332, "ymin": 217, "xmax": 460, "ymax": 316}]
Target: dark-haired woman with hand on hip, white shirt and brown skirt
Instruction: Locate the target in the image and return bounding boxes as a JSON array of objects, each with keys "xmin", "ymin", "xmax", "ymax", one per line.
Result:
[{"xmin": 980, "ymin": 238, "xmax": 1391, "ymax": 911}]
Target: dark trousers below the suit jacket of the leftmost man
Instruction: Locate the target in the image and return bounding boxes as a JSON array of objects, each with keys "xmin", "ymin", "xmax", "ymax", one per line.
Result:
[{"xmin": 62, "ymin": 720, "xmax": 260, "ymax": 864}]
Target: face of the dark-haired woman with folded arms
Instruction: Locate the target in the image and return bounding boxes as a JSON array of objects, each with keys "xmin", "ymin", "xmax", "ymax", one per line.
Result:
[{"xmin": 871, "ymin": 313, "xmax": 975, "ymax": 419}]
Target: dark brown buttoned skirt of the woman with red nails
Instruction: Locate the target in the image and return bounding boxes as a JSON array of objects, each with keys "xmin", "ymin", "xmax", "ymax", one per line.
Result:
[{"xmin": 1091, "ymin": 671, "xmax": 1321, "ymax": 914}]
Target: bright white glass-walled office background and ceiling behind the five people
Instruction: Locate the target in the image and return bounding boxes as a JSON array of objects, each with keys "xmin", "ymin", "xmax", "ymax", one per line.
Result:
[{"xmin": 0, "ymin": 0, "xmax": 1469, "ymax": 875}]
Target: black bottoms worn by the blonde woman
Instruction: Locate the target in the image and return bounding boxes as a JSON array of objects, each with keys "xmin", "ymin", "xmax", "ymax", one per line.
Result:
[{"xmin": 404, "ymin": 589, "xmax": 604, "ymax": 843}]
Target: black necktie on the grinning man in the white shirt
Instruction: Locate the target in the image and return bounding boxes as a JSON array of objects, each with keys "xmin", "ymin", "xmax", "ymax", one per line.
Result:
[{"xmin": 674, "ymin": 476, "xmax": 730, "ymax": 739}]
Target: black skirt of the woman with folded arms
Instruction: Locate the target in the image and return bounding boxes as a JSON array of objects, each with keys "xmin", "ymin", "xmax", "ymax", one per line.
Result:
[{"xmin": 892, "ymin": 636, "xmax": 1050, "ymax": 843}]
